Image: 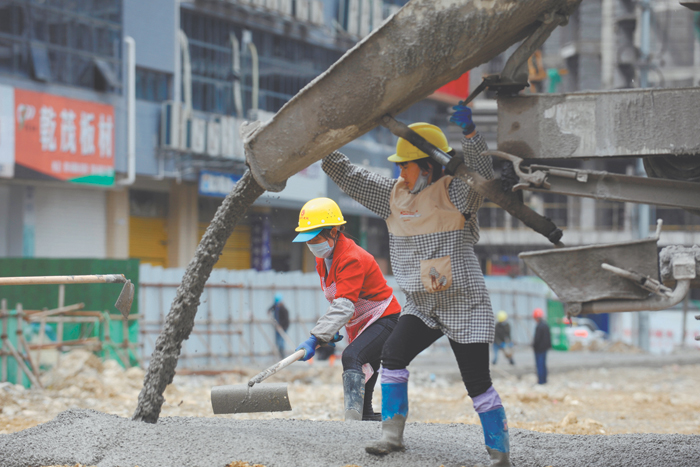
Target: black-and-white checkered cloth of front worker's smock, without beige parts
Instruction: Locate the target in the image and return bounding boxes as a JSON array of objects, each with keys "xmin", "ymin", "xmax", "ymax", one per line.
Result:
[{"xmin": 322, "ymin": 133, "xmax": 494, "ymax": 344}]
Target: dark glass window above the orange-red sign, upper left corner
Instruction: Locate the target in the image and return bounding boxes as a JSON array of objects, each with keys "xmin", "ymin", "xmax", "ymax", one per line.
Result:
[{"xmin": 0, "ymin": 0, "xmax": 122, "ymax": 92}]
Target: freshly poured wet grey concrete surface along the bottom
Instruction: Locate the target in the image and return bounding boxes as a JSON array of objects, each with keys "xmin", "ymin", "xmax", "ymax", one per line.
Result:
[{"xmin": 0, "ymin": 409, "xmax": 700, "ymax": 467}]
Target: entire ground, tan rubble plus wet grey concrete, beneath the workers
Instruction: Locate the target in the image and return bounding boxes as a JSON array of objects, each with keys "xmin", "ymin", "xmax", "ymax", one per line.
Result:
[{"xmin": 0, "ymin": 351, "xmax": 700, "ymax": 467}]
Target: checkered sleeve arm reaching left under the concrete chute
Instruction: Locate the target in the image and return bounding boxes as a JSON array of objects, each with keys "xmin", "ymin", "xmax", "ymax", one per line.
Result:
[{"xmin": 321, "ymin": 151, "xmax": 396, "ymax": 219}]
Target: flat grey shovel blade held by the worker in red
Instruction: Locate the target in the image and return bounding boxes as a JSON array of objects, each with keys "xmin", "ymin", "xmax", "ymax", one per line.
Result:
[{"xmin": 211, "ymin": 383, "xmax": 292, "ymax": 414}]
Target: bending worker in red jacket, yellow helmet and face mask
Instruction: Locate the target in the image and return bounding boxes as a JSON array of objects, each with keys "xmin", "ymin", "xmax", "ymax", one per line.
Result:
[{"xmin": 294, "ymin": 198, "xmax": 401, "ymax": 421}]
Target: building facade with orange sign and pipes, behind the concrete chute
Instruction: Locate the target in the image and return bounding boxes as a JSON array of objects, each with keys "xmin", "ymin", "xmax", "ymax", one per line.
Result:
[{"xmin": 0, "ymin": 0, "xmax": 454, "ymax": 271}]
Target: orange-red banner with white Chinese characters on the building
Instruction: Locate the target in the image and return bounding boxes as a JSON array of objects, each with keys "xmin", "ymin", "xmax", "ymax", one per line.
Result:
[{"xmin": 14, "ymin": 89, "xmax": 114, "ymax": 186}]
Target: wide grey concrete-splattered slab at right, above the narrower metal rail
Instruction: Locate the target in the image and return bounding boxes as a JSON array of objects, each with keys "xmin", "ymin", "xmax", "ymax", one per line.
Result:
[{"xmin": 498, "ymin": 88, "xmax": 700, "ymax": 159}]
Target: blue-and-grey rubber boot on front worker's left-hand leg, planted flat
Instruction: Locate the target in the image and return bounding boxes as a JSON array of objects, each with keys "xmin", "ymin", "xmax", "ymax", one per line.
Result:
[{"xmin": 365, "ymin": 382, "xmax": 408, "ymax": 456}]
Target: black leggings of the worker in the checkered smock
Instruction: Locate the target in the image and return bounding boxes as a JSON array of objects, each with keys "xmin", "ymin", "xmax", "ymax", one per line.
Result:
[{"xmin": 382, "ymin": 314, "xmax": 491, "ymax": 398}]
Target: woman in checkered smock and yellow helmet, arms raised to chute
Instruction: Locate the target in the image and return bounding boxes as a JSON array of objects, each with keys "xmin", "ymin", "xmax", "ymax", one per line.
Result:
[{"xmin": 322, "ymin": 103, "xmax": 511, "ymax": 466}]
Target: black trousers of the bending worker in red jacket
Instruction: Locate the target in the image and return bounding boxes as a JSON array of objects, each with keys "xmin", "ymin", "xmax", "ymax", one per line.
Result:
[{"xmin": 342, "ymin": 313, "xmax": 399, "ymax": 407}]
